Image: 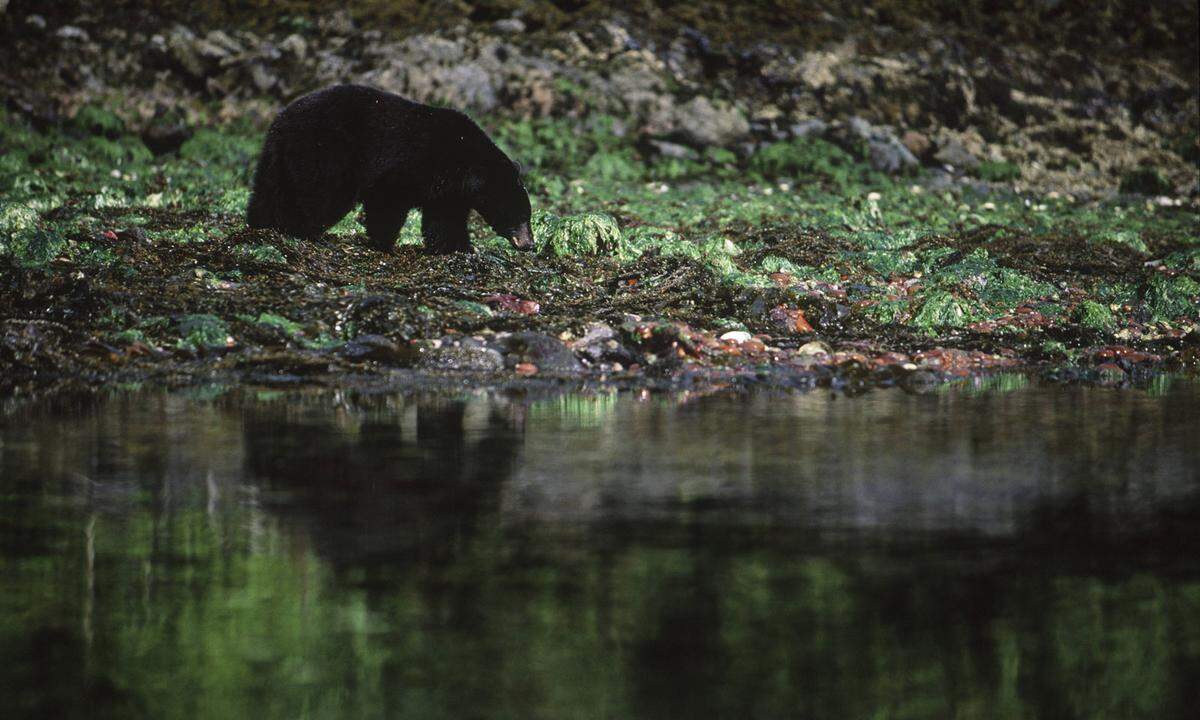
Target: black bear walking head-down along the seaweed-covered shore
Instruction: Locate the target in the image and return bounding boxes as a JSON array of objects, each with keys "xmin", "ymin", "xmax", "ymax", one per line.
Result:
[{"xmin": 246, "ymin": 85, "xmax": 533, "ymax": 253}]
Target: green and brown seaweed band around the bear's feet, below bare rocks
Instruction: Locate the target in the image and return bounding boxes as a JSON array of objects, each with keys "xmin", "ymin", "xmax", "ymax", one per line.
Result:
[{"xmin": 0, "ymin": 103, "xmax": 1200, "ymax": 386}]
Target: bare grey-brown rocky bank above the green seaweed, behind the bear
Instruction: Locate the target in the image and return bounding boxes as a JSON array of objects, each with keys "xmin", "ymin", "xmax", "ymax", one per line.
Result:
[{"xmin": 7, "ymin": 11, "xmax": 1200, "ymax": 198}]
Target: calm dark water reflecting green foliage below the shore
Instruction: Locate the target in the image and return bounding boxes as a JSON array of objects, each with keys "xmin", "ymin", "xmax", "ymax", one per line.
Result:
[{"xmin": 0, "ymin": 378, "xmax": 1200, "ymax": 719}]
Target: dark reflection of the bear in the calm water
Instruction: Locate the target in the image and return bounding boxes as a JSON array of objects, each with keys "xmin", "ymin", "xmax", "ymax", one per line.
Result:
[{"xmin": 244, "ymin": 400, "xmax": 524, "ymax": 566}]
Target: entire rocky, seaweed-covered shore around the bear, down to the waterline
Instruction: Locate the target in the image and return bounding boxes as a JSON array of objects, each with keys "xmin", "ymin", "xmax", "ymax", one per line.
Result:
[{"xmin": 0, "ymin": 7, "xmax": 1200, "ymax": 395}]
